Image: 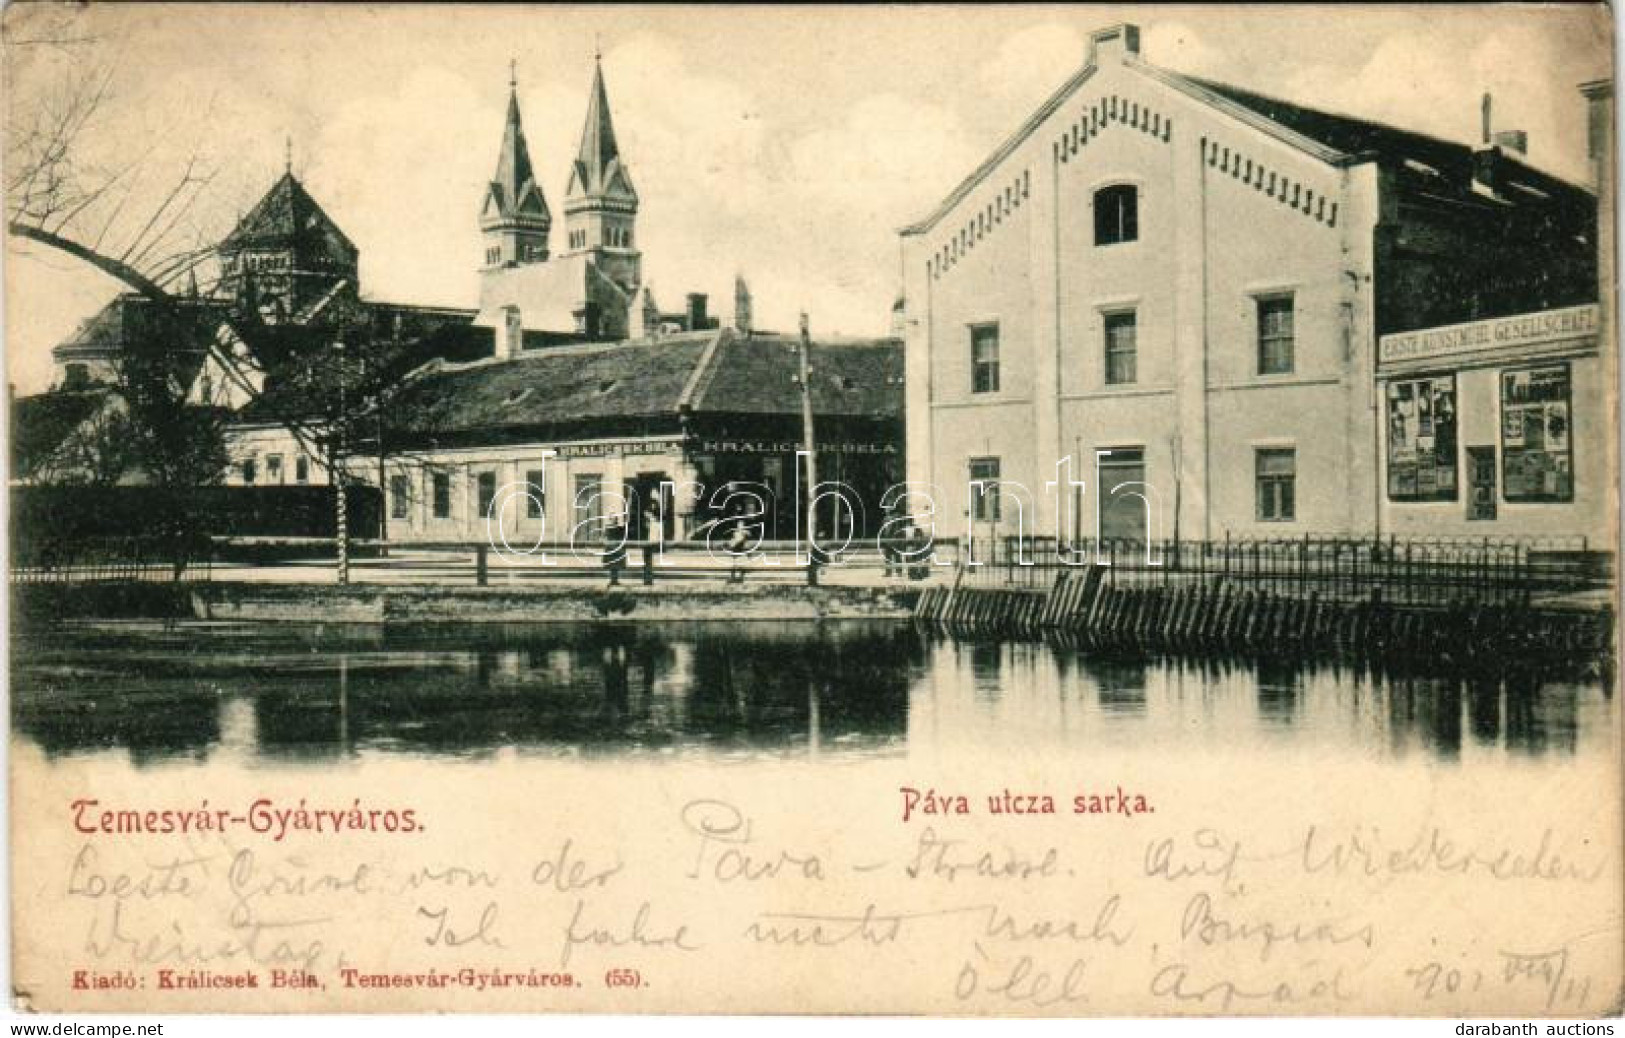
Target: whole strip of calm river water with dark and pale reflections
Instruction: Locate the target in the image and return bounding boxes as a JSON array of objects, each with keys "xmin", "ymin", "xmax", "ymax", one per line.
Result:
[{"xmin": 11, "ymin": 622, "xmax": 1614, "ymax": 765}]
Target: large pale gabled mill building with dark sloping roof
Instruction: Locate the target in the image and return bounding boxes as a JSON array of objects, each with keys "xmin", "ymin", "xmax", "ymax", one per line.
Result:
[{"xmin": 902, "ymin": 24, "xmax": 1606, "ymax": 539}]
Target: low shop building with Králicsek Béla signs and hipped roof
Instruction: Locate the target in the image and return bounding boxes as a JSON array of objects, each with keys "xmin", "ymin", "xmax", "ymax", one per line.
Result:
[{"xmin": 373, "ymin": 328, "xmax": 904, "ymax": 549}]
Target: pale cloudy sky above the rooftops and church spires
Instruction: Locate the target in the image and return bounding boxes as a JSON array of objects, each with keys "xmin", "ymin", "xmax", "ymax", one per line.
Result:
[{"xmin": 5, "ymin": 5, "xmax": 1612, "ymax": 391}]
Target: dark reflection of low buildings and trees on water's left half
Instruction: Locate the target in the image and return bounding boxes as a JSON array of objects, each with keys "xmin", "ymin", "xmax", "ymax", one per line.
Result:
[{"xmin": 15, "ymin": 624, "xmax": 920, "ymax": 763}]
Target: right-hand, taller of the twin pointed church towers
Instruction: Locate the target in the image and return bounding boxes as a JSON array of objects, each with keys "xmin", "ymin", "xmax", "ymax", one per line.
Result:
[{"xmin": 564, "ymin": 58, "xmax": 642, "ymax": 297}]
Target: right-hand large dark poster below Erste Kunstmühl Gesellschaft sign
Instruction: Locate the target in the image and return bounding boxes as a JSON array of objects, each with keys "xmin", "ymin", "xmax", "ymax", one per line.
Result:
[{"xmin": 1502, "ymin": 364, "xmax": 1575, "ymax": 502}]
